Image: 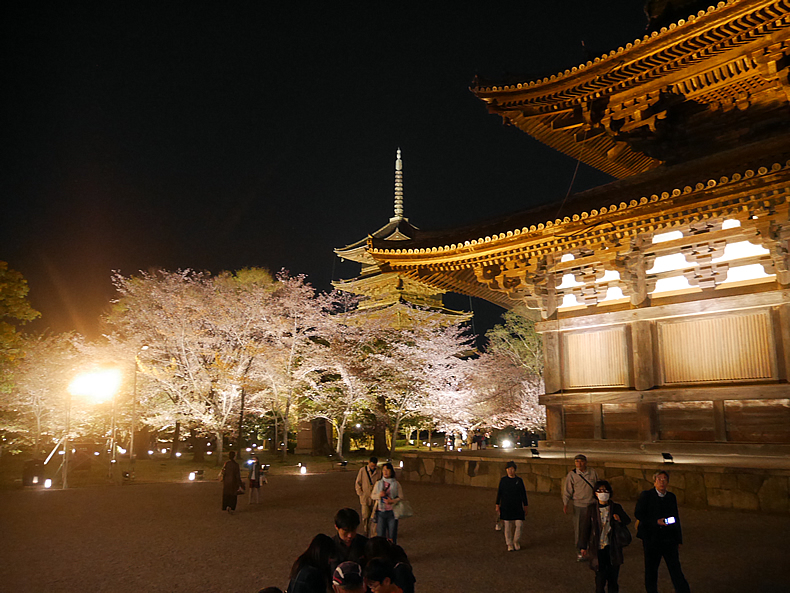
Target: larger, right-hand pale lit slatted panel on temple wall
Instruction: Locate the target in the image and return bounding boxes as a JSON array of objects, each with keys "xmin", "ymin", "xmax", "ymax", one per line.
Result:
[{"xmin": 658, "ymin": 311, "xmax": 777, "ymax": 385}]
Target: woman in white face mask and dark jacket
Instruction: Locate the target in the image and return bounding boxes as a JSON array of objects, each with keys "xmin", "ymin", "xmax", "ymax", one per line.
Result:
[{"xmin": 578, "ymin": 480, "xmax": 631, "ymax": 593}]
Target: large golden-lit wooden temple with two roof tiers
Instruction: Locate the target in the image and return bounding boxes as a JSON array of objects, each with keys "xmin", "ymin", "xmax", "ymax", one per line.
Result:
[{"xmin": 366, "ymin": 0, "xmax": 790, "ymax": 453}]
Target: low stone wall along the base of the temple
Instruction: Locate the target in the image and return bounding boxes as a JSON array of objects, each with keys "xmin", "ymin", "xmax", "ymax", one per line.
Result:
[{"xmin": 400, "ymin": 453, "xmax": 790, "ymax": 514}]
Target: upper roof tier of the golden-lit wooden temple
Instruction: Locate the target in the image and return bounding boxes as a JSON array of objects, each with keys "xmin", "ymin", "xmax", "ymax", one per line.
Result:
[{"xmin": 471, "ymin": 0, "xmax": 790, "ymax": 179}]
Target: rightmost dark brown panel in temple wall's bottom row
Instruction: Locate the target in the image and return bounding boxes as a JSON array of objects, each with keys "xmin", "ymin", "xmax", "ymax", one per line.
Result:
[{"xmin": 724, "ymin": 399, "xmax": 790, "ymax": 443}]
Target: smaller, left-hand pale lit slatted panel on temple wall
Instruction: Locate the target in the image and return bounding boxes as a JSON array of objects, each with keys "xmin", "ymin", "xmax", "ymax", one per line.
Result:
[{"xmin": 562, "ymin": 327, "xmax": 629, "ymax": 389}]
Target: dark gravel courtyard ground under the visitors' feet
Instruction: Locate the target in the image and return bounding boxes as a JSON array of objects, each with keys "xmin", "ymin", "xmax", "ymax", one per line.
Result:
[{"xmin": 0, "ymin": 470, "xmax": 790, "ymax": 593}]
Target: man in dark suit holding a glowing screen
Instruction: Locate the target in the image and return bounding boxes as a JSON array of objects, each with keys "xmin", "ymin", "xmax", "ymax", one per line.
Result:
[{"xmin": 634, "ymin": 470, "xmax": 691, "ymax": 593}]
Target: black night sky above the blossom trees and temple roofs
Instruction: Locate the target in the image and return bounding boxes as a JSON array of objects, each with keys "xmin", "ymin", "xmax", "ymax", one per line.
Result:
[{"xmin": 0, "ymin": 0, "xmax": 646, "ymax": 336}]
